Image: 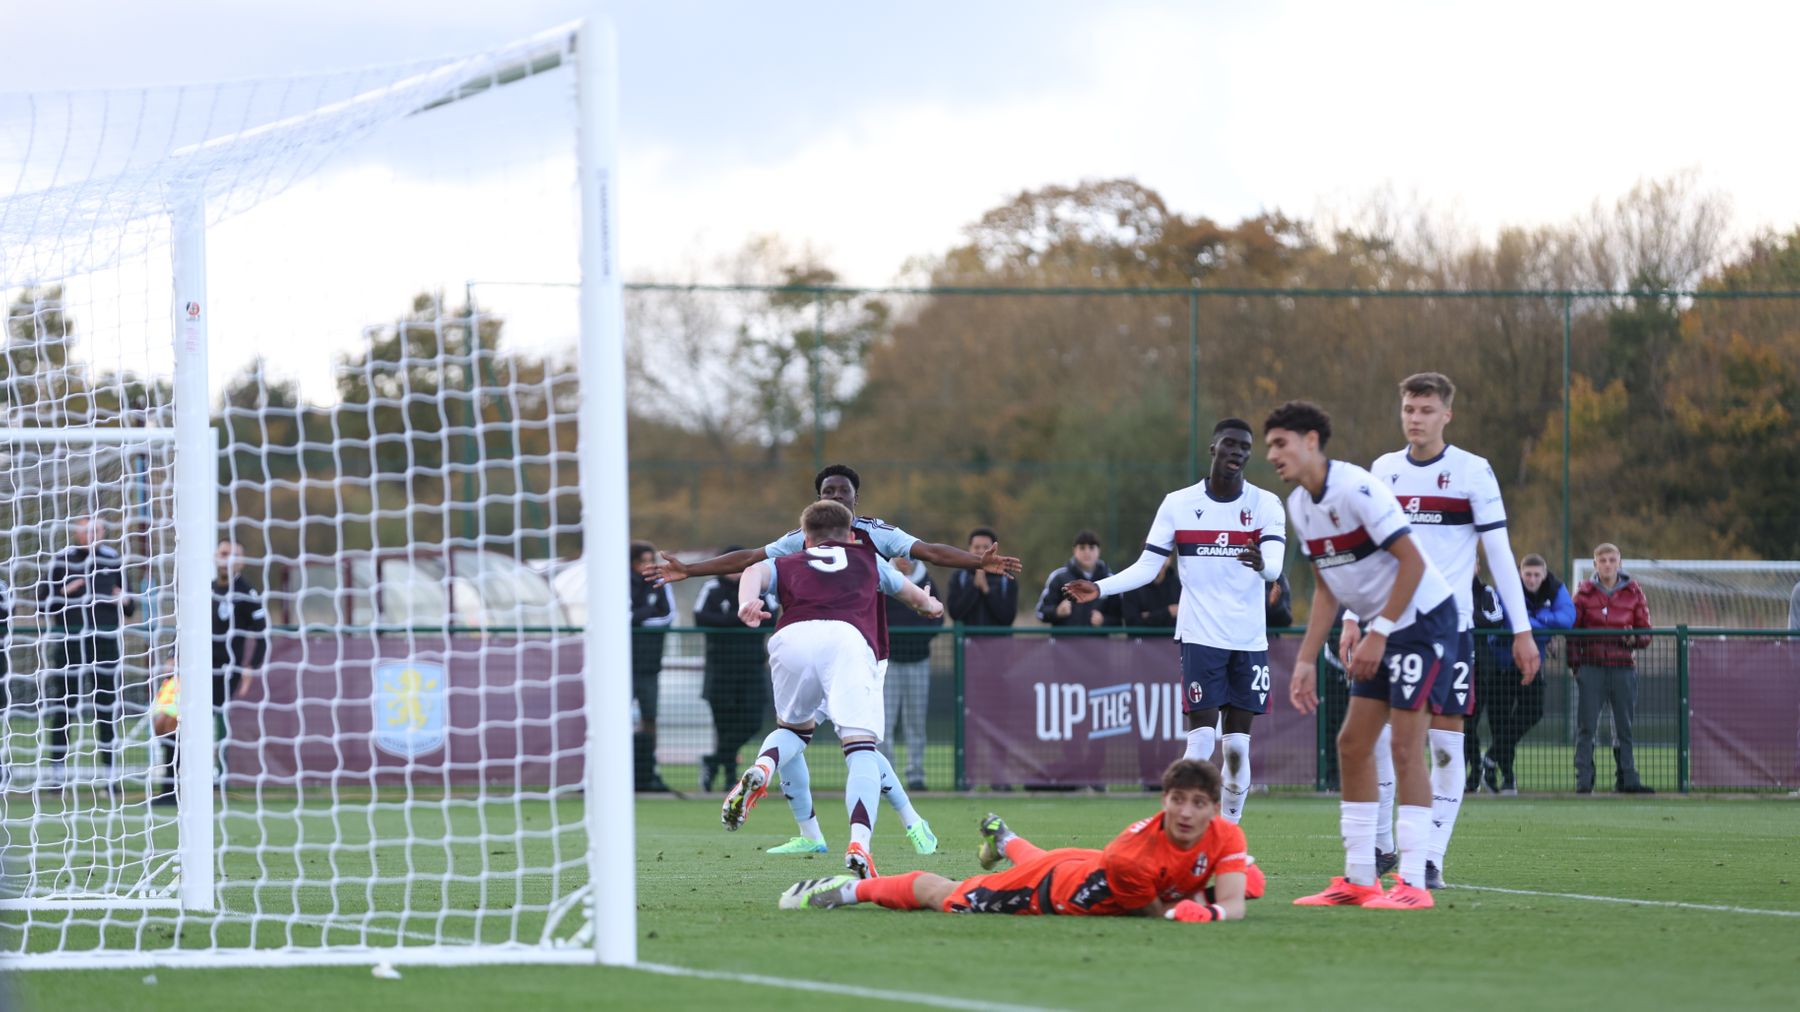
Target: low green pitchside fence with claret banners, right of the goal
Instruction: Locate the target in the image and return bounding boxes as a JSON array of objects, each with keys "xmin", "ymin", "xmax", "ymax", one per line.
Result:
[{"xmin": 640, "ymin": 627, "xmax": 1800, "ymax": 794}]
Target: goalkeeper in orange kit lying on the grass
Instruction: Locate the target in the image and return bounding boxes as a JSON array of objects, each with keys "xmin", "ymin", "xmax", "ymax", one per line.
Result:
[{"xmin": 781, "ymin": 758, "xmax": 1260, "ymax": 922}]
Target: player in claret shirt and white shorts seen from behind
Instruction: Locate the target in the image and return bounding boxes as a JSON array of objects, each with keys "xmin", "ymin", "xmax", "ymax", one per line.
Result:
[{"xmin": 720, "ymin": 501, "xmax": 907, "ymax": 879}]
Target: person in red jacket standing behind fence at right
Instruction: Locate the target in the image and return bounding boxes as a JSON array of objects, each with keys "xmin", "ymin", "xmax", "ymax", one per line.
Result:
[{"xmin": 1570, "ymin": 544, "xmax": 1656, "ymax": 794}]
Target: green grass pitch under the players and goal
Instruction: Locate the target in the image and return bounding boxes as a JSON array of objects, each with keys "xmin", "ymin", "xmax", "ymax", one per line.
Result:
[{"xmin": 13, "ymin": 794, "xmax": 1800, "ymax": 1012}]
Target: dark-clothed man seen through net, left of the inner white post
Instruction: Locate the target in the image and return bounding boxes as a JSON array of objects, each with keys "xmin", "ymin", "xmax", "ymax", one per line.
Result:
[{"xmin": 38, "ymin": 517, "xmax": 137, "ymax": 787}]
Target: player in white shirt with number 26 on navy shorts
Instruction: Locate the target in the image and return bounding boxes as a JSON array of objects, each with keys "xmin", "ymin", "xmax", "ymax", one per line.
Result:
[{"xmin": 1064, "ymin": 418, "xmax": 1287, "ymax": 823}]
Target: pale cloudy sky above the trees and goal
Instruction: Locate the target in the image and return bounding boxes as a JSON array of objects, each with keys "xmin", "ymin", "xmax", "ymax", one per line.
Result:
[{"xmin": 0, "ymin": 0, "xmax": 1800, "ymax": 397}]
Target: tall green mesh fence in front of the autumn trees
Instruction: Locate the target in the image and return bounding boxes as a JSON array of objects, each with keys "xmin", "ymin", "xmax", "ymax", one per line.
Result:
[{"xmin": 608, "ymin": 285, "xmax": 1800, "ymax": 625}]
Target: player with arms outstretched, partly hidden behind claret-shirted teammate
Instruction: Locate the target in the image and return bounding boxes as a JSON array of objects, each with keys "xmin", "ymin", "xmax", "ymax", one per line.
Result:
[{"xmin": 655, "ymin": 465, "xmax": 1019, "ymax": 854}]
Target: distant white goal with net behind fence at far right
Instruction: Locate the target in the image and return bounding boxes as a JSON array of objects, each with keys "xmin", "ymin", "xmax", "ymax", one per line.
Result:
[{"xmin": 1575, "ymin": 558, "xmax": 1800, "ymax": 628}]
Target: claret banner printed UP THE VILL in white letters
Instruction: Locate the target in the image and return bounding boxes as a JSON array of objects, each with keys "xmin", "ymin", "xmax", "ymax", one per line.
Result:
[{"xmin": 963, "ymin": 636, "xmax": 1330, "ymax": 787}]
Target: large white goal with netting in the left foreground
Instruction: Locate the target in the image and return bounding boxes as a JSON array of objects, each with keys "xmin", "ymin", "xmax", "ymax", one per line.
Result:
[{"xmin": 0, "ymin": 25, "xmax": 635, "ymax": 967}]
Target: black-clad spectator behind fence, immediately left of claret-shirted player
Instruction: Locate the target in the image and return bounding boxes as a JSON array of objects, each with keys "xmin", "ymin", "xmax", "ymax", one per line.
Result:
[{"xmin": 693, "ymin": 546, "xmax": 781, "ymax": 791}]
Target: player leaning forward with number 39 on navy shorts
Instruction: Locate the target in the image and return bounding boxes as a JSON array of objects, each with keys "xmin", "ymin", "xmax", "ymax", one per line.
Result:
[{"xmin": 1262, "ymin": 402, "xmax": 1456, "ymax": 909}]
